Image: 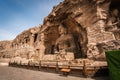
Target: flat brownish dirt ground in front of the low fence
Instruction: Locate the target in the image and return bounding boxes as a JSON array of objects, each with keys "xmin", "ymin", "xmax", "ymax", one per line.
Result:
[{"xmin": 0, "ymin": 66, "xmax": 109, "ymax": 80}]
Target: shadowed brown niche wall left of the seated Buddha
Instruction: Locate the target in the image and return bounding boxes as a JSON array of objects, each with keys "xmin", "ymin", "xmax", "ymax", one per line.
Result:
[{"xmin": 40, "ymin": 26, "xmax": 59, "ymax": 55}]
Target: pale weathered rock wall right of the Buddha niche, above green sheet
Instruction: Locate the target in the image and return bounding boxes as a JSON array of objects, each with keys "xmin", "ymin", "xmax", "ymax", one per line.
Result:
[{"xmin": 87, "ymin": 0, "xmax": 120, "ymax": 60}]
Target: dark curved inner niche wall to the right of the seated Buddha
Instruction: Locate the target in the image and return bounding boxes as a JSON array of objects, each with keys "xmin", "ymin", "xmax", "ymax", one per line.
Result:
[{"xmin": 63, "ymin": 18, "xmax": 88, "ymax": 58}]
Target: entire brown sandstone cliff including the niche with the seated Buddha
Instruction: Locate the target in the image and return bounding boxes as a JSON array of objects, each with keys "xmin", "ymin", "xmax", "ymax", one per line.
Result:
[{"xmin": 0, "ymin": 0, "xmax": 120, "ymax": 60}]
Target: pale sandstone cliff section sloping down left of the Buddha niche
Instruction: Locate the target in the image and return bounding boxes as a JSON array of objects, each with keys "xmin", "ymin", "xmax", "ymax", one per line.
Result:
[{"xmin": 11, "ymin": 27, "xmax": 40, "ymax": 59}]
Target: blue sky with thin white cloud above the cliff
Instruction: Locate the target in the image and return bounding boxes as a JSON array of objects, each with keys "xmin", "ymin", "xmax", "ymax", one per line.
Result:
[{"xmin": 0, "ymin": 0, "xmax": 63, "ymax": 40}]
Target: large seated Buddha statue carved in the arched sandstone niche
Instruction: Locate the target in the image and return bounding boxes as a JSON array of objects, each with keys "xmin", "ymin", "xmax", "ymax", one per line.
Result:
[{"xmin": 56, "ymin": 24, "xmax": 76, "ymax": 60}]
